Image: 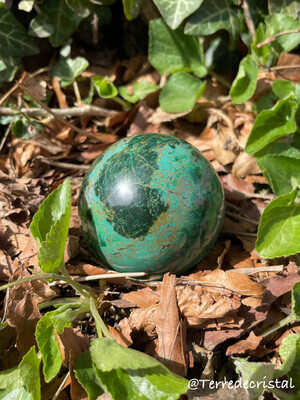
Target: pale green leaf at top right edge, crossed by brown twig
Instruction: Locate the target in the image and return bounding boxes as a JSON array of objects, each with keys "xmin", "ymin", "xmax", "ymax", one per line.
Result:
[{"xmin": 265, "ymin": 14, "xmax": 300, "ymax": 54}]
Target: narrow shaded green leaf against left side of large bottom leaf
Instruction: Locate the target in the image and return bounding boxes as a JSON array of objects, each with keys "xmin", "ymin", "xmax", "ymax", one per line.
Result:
[{"xmin": 74, "ymin": 351, "xmax": 104, "ymax": 400}]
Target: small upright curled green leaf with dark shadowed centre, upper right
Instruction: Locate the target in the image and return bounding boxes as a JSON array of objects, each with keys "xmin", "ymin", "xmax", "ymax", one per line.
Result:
[{"xmin": 229, "ymin": 55, "xmax": 258, "ymax": 104}]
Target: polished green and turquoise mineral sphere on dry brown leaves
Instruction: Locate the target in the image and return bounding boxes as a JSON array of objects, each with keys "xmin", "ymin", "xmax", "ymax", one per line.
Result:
[{"xmin": 78, "ymin": 134, "xmax": 224, "ymax": 274}]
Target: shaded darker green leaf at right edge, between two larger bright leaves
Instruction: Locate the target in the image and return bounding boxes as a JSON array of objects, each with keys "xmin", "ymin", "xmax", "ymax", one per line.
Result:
[{"xmin": 257, "ymin": 153, "xmax": 300, "ymax": 196}]
